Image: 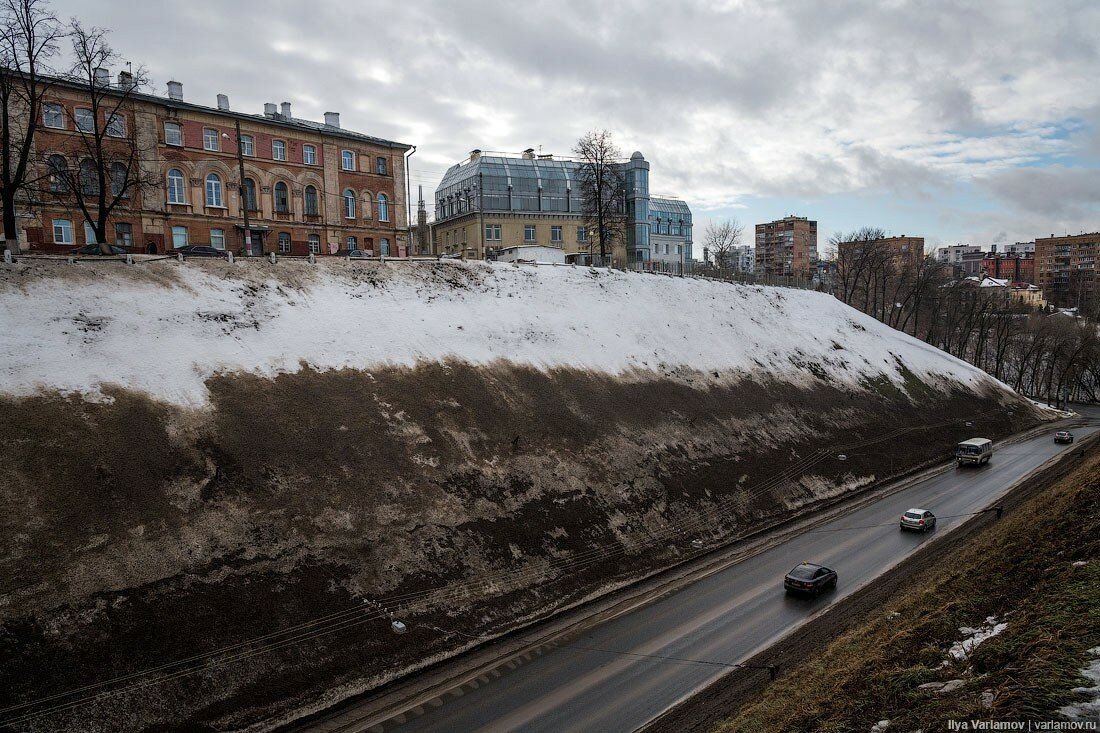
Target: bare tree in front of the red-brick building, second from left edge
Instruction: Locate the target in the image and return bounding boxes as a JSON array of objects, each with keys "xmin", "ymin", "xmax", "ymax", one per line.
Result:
[{"xmin": 43, "ymin": 20, "xmax": 161, "ymax": 254}]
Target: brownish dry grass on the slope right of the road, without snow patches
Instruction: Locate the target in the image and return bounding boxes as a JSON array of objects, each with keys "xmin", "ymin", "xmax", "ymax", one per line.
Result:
[{"xmin": 717, "ymin": 440, "xmax": 1100, "ymax": 733}]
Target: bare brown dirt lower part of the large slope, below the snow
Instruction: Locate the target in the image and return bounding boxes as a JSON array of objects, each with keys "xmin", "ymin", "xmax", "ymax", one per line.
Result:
[{"xmin": 0, "ymin": 362, "xmax": 1037, "ymax": 731}]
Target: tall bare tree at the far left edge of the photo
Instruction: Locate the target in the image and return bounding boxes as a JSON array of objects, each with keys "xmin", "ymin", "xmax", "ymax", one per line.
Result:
[{"xmin": 0, "ymin": 0, "xmax": 64, "ymax": 252}]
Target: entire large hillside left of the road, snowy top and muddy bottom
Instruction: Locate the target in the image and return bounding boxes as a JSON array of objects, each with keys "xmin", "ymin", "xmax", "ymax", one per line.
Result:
[{"xmin": 0, "ymin": 261, "xmax": 1043, "ymax": 731}]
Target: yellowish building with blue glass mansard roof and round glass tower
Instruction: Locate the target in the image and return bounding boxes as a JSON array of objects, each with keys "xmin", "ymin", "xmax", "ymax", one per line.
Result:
[{"xmin": 432, "ymin": 150, "xmax": 691, "ymax": 266}]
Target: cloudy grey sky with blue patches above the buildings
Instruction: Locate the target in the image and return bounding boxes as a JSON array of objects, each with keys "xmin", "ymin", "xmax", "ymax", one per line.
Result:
[{"xmin": 53, "ymin": 0, "xmax": 1100, "ymax": 247}]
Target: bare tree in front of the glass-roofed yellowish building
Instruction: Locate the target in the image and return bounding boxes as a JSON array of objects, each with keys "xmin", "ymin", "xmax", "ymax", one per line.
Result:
[{"xmin": 573, "ymin": 130, "xmax": 626, "ymax": 258}]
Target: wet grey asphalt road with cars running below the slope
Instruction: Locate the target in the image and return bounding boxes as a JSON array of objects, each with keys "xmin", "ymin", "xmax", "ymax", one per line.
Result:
[{"xmin": 305, "ymin": 411, "xmax": 1100, "ymax": 733}]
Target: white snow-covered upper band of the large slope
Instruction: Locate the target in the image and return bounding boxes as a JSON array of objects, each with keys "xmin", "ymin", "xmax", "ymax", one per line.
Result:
[{"xmin": 0, "ymin": 260, "xmax": 994, "ymax": 405}]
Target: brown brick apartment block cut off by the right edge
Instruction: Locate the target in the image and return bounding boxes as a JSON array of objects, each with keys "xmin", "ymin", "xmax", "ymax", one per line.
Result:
[{"xmin": 1035, "ymin": 232, "xmax": 1100, "ymax": 307}]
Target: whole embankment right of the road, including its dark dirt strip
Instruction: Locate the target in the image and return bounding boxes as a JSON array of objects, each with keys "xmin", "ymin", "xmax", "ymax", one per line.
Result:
[{"xmin": 646, "ymin": 439, "xmax": 1100, "ymax": 733}]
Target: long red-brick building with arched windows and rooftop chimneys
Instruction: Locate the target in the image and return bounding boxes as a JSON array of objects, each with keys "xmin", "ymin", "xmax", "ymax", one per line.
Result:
[{"xmin": 22, "ymin": 70, "xmax": 413, "ymax": 256}]
